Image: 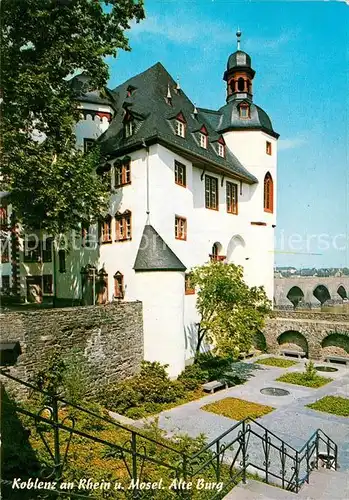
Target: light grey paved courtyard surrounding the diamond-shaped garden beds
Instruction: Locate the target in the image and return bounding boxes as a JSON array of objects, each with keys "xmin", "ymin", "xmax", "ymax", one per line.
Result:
[{"xmin": 148, "ymin": 361, "xmax": 349, "ymax": 471}]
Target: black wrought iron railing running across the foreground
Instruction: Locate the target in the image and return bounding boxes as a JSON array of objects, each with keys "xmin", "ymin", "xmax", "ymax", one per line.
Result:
[{"xmin": 0, "ymin": 370, "xmax": 338, "ymax": 500}]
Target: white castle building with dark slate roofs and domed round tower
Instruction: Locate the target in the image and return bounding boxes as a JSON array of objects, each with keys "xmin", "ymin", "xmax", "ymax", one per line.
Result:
[{"xmin": 3, "ymin": 38, "xmax": 278, "ymax": 376}]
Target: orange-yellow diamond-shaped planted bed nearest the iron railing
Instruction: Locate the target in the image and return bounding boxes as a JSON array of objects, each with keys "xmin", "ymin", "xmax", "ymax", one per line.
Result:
[{"xmin": 201, "ymin": 398, "xmax": 275, "ymax": 420}]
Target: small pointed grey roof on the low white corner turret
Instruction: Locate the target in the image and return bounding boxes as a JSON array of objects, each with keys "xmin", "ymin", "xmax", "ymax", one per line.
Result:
[{"xmin": 133, "ymin": 224, "xmax": 186, "ymax": 271}]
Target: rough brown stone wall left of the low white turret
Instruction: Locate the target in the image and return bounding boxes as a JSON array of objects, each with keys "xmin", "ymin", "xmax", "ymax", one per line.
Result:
[{"xmin": 0, "ymin": 302, "xmax": 144, "ymax": 394}]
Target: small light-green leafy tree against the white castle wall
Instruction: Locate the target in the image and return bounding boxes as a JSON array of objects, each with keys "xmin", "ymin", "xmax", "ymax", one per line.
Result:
[{"xmin": 192, "ymin": 262, "xmax": 271, "ymax": 359}]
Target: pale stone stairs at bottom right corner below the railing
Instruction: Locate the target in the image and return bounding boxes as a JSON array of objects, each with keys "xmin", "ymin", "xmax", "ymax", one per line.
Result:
[{"xmin": 224, "ymin": 469, "xmax": 349, "ymax": 500}]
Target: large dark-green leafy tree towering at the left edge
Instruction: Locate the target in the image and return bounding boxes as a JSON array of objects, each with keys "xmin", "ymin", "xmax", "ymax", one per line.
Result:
[{"xmin": 0, "ymin": 0, "xmax": 144, "ymax": 234}]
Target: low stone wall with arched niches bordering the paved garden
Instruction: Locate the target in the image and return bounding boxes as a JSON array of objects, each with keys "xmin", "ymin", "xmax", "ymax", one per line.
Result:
[{"xmin": 263, "ymin": 311, "xmax": 349, "ymax": 359}]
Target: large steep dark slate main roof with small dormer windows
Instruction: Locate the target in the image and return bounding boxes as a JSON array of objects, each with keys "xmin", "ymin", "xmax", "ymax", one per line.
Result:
[{"xmin": 98, "ymin": 63, "xmax": 258, "ymax": 184}]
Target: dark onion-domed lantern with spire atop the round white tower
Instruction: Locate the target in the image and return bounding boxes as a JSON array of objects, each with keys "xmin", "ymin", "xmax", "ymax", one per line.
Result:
[{"xmin": 223, "ymin": 29, "xmax": 255, "ymax": 102}]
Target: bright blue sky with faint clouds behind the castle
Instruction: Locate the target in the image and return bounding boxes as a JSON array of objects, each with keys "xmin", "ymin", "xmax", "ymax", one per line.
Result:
[{"xmin": 104, "ymin": 0, "xmax": 349, "ymax": 267}]
